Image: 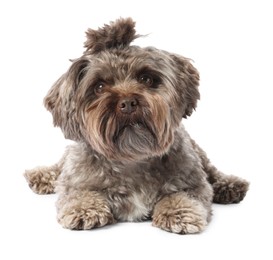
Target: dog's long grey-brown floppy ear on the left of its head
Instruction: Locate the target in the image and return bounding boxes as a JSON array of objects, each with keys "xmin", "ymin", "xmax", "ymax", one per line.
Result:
[{"xmin": 44, "ymin": 58, "xmax": 89, "ymax": 141}]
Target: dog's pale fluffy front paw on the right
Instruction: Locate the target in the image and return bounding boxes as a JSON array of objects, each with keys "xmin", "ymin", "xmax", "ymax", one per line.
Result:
[{"xmin": 152, "ymin": 192, "xmax": 210, "ymax": 234}]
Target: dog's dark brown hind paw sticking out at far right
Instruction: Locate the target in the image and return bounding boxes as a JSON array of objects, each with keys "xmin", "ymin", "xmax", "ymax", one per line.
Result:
[{"xmin": 212, "ymin": 176, "xmax": 249, "ymax": 204}]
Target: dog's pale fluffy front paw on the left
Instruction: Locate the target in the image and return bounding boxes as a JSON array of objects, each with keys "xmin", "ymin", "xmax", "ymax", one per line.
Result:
[{"xmin": 57, "ymin": 190, "xmax": 115, "ymax": 229}]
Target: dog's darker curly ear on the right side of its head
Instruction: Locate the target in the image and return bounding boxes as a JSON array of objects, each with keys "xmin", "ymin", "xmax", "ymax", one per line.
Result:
[{"xmin": 171, "ymin": 54, "xmax": 200, "ymax": 118}]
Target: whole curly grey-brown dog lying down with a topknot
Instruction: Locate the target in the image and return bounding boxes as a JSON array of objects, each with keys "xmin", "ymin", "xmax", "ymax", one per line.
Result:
[{"xmin": 25, "ymin": 18, "xmax": 248, "ymax": 234}]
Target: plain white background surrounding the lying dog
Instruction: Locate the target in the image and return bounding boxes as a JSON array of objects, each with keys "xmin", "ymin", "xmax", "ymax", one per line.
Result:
[{"xmin": 0, "ymin": 0, "xmax": 273, "ymax": 259}]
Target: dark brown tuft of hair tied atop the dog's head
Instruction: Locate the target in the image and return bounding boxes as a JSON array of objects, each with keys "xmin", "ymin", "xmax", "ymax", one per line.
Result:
[{"xmin": 84, "ymin": 18, "xmax": 139, "ymax": 54}]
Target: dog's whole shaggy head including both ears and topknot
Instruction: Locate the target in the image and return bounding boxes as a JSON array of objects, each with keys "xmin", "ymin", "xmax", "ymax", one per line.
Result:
[{"xmin": 45, "ymin": 18, "xmax": 199, "ymax": 160}]
